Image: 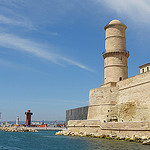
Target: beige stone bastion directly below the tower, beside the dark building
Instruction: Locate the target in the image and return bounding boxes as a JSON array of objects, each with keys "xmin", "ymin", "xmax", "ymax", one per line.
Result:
[{"xmin": 87, "ymin": 87, "xmax": 118, "ymax": 120}]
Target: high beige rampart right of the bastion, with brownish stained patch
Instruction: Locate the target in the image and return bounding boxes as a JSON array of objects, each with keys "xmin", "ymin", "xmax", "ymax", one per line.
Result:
[{"xmin": 116, "ymin": 72, "xmax": 150, "ymax": 121}]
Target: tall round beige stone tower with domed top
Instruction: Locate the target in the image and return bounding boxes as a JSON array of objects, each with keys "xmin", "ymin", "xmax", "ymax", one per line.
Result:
[{"xmin": 103, "ymin": 20, "xmax": 129, "ymax": 84}]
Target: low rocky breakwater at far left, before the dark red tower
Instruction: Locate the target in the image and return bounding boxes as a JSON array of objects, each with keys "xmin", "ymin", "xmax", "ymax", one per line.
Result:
[{"xmin": 0, "ymin": 127, "xmax": 38, "ymax": 132}]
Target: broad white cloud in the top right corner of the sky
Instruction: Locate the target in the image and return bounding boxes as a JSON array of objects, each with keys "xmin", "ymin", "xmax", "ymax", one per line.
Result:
[{"xmin": 94, "ymin": 0, "xmax": 150, "ymax": 23}]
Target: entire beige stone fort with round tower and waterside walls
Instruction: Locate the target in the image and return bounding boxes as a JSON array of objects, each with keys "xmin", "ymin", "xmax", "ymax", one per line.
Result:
[{"xmin": 63, "ymin": 20, "xmax": 150, "ymax": 140}]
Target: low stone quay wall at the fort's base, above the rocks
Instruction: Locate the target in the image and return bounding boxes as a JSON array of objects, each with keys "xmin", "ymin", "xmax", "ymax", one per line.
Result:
[{"xmin": 68, "ymin": 120, "xmax": 150, "ymax": 137}]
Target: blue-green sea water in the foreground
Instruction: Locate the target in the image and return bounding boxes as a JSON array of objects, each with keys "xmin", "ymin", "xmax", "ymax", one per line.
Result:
[{"xmin": 0, "ymin": 131, "xmax": 150, "ymax": 150}]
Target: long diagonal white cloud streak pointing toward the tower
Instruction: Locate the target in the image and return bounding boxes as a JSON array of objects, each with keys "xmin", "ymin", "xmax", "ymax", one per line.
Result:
[{"xmin": 0, "ymin": 33, "xmax": 93, "ymax": 72}]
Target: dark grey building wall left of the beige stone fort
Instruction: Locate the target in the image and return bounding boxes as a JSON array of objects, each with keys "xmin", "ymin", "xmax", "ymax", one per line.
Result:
[{"xmin": 66, "ymin": 106, "xmax": 88, "ymax": 124}]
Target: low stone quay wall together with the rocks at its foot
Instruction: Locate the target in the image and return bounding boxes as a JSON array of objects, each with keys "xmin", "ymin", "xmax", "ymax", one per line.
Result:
[{"xmin": 57, "ymin": 120, "xmax": 150, "ymax": 143}]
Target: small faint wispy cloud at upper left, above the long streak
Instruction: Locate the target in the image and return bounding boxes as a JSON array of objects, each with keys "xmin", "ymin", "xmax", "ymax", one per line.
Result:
[{"xmin": 0, "ymin": 15, "xmax": 33, "ymax": 29}]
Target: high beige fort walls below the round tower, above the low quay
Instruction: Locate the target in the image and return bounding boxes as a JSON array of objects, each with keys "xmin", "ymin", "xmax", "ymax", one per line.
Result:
[{"xmin": 87, "ymin": 72, "xmax": 150, "ymax": 122}]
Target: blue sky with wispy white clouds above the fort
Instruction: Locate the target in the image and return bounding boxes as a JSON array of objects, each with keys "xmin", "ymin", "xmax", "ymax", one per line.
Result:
[{"xmin": 0, "ymin": 0, "xmax": 150, "ymax": 121}]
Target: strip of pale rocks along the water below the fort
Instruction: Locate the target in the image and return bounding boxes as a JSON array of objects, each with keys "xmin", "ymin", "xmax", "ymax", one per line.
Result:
[{"xmin": 56, "ymin": 131, "xmax": 150, "ymax": 145}]
